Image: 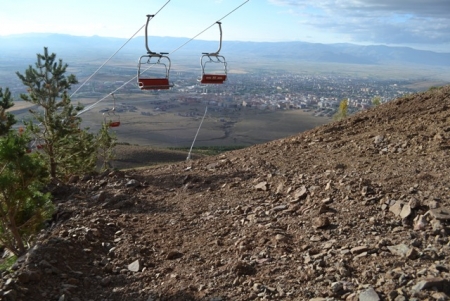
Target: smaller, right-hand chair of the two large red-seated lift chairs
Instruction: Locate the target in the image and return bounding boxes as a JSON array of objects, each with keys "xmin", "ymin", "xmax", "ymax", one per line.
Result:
[{"xmin": 200, "ymin": 21, "xmax": 227, "ymax": 84}]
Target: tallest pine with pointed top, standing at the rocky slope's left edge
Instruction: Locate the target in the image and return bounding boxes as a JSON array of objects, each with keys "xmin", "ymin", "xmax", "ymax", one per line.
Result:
[{"xmin": 16, "ymin": 47, "xmax": 96, "ymax": 178}]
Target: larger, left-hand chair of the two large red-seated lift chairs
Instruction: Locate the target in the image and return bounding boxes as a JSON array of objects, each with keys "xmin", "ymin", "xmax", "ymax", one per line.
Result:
[{"xmin": 137, "ymin": 15, "xmax": 173, "ymax": 90}]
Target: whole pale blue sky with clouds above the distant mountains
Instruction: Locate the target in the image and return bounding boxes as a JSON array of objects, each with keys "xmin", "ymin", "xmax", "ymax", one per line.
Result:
[{"xmin": 0, "ymin": 0, "xmax": 450, "ymax": 53}]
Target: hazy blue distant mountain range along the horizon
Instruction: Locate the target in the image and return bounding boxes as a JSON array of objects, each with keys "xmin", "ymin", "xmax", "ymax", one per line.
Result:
[{"xmin": 0, "ymin": 34, "xmax": 450, "ymax": 67}]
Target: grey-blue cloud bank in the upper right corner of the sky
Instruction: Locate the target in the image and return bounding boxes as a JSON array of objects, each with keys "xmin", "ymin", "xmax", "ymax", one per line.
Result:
[{"xmin": 269, "ymin": 0, "xmax": 450, "ymax": 45}]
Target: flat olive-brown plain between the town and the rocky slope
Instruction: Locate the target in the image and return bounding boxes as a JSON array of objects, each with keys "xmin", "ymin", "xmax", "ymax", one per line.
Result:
[{"xmin": 77, "ymin": 95, "xmax": 330, "ymax": 147}]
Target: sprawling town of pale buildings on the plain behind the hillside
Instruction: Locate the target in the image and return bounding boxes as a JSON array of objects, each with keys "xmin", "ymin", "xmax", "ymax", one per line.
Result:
[{"xmin": 164, "ymin": 73, "xmax": 416, "ymax": 116}]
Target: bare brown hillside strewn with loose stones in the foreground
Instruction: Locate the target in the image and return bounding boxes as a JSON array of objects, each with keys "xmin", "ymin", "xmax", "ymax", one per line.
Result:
[{"xmin": 1, "ymin": 86, "xmax": 450, "ymax": 301}]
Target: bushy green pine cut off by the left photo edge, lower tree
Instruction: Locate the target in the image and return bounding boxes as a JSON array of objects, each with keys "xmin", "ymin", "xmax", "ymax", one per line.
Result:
[{"xmin": 0, "ymin": 130, "xmax": 54, "ymax": 256}]
